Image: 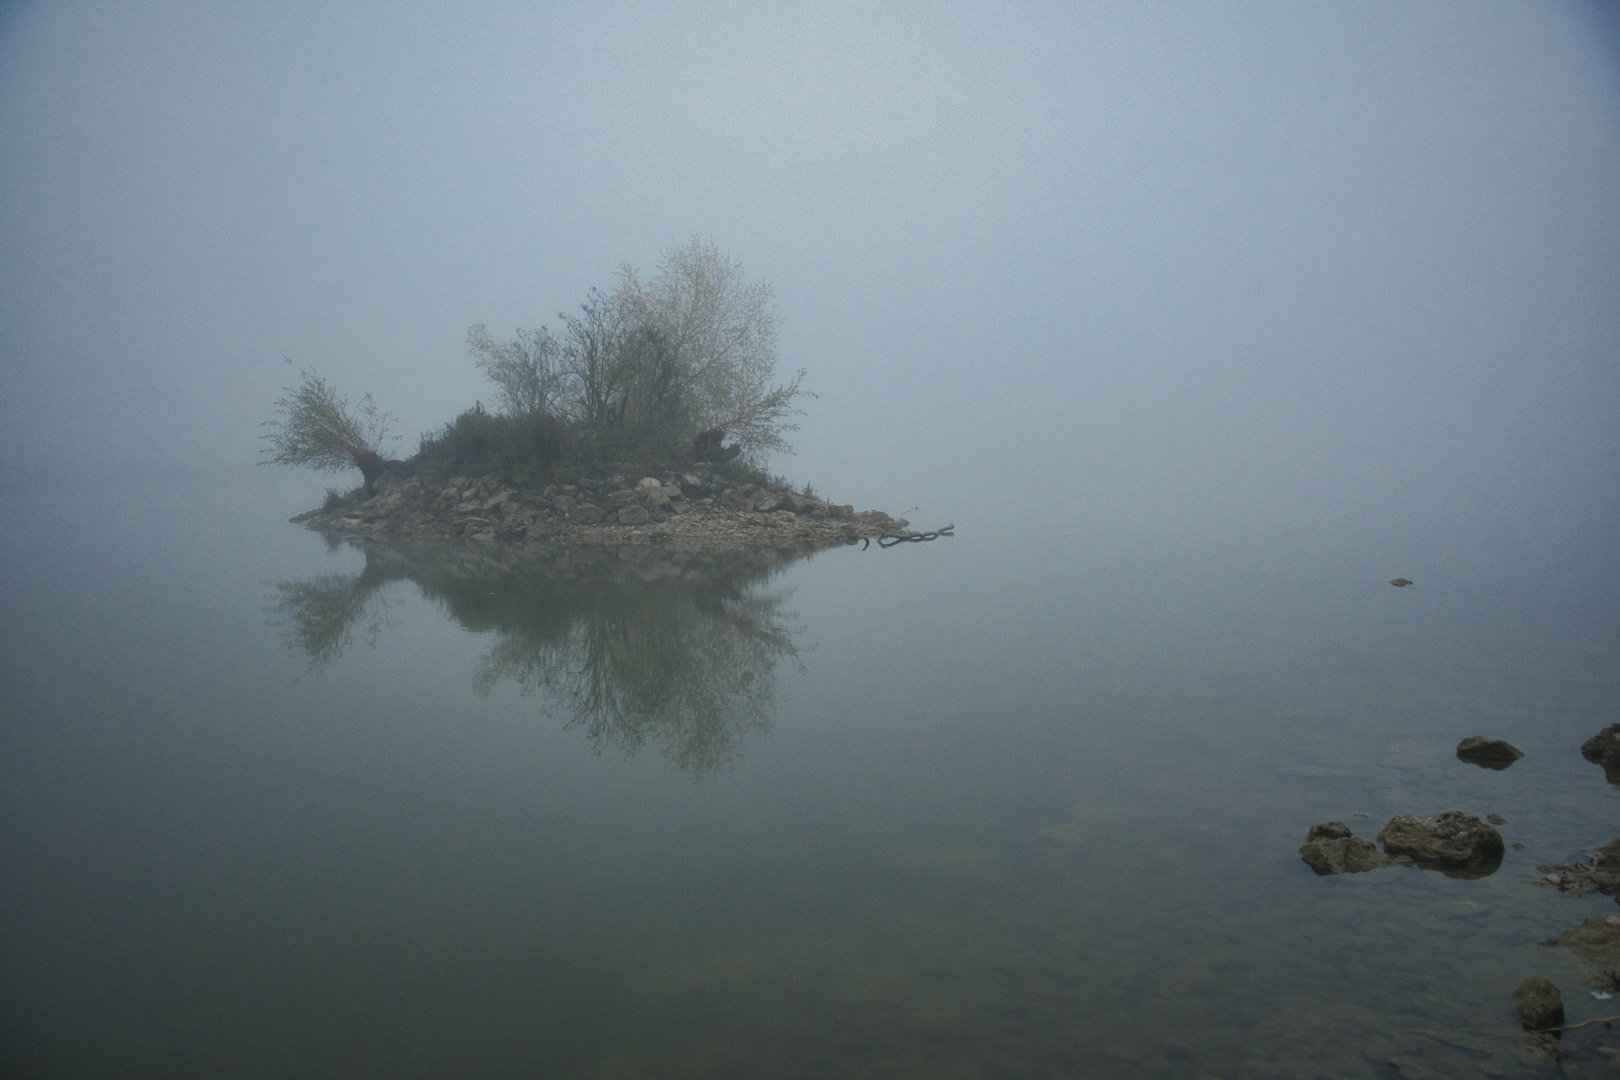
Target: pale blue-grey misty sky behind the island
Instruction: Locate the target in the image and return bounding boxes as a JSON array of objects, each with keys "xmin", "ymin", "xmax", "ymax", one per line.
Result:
[{"xmin": 0, "ymin": 0, "xmax": 1620, "ymax": 566}]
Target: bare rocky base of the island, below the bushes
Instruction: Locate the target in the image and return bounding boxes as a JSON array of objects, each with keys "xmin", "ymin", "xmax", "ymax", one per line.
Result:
[{"xmin": 293, "ymin": 465, "xmax": 922, "ymax": 551}]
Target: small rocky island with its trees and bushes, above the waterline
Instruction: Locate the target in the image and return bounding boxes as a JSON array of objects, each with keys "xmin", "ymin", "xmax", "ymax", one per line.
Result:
[{"xmin": 262, "ymin": 236, "xmax": 951, "ymax": 551}]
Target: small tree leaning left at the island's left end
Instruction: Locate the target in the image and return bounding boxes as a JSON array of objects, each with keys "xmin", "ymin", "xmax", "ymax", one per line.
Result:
[{"xmin": 259, "ymin": 361, "xmax": 397, "ymax": 494}]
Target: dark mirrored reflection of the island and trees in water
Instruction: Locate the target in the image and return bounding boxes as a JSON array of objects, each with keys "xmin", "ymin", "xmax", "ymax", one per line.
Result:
[{"xmin": 269, "ymin": 539, "xmax": 816, "ymax": 776}]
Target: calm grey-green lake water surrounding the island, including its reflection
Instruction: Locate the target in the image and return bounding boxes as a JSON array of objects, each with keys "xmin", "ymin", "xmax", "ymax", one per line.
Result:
[{"xmin": 0, "ymin": 472, "xmax": 1620, "ymax": 1080}]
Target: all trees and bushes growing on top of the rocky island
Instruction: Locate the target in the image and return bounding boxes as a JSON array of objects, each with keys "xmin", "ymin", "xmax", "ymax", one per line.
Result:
[{"xmin": 264, "ymin": 235, "xmax": 807, "ymax": 492}]
